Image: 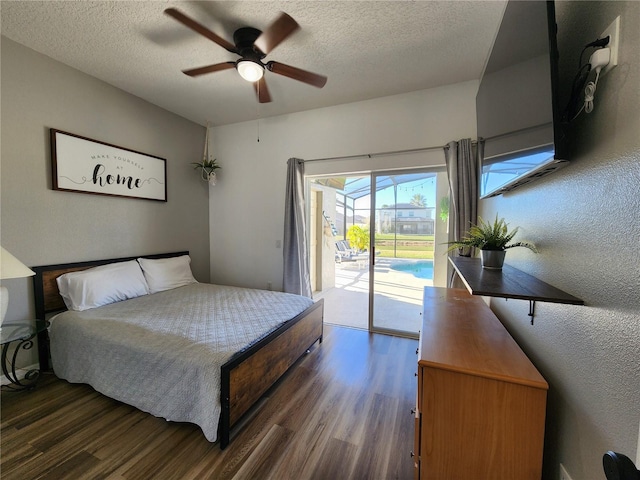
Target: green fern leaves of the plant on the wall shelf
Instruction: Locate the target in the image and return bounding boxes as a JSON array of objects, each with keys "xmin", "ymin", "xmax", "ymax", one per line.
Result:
[{"xmin": 447, "ymin": 214, "xmax": 538, "ymax": 253}]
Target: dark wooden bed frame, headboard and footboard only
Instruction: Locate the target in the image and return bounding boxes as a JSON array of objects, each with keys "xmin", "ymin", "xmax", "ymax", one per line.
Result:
[{"xmin": 31, "ymin": 252, "xmax": 324, "ymax": 449}]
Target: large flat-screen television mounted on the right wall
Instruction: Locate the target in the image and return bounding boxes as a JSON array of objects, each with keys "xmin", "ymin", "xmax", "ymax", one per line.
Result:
[{"xmin": 476, "ymin": 0, "xmax": 567, "ymax": 198}]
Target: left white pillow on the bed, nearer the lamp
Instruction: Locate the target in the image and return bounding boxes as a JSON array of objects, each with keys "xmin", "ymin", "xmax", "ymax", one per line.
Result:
[{"xmin": 56, "ymin": 260, "xmax": 149, "ymax": 311}]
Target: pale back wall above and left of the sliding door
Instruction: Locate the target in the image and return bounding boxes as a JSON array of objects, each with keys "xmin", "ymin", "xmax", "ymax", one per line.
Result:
[{"xmin": 209, "ymin": 81, "xmax": 478, "ymax": 289}]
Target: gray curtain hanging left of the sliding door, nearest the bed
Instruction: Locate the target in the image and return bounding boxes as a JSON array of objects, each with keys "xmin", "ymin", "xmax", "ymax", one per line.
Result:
[{"xmin": 282, "ymin": 158, "xmax": 312, "ymax": 298}]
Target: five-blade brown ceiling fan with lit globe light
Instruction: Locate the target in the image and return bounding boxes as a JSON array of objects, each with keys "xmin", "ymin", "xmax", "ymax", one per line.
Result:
[{"xmin": 164, "ymin": 8, "xmax": 327, "ymax": 103}]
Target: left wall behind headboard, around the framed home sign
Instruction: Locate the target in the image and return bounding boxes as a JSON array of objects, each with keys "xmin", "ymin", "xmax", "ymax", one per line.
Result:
[{"xmin": 0, "ymin": 37, "xmax": 209, "ymax": 351}]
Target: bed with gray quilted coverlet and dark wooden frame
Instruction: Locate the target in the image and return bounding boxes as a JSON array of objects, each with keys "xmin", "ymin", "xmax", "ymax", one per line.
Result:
[{"xmin": 33, "ymin": 252, "xmax": 323, "ymax": 449}]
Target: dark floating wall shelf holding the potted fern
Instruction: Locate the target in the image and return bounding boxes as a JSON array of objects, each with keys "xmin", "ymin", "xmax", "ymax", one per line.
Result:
[{"xmin": 449, "ymin": 257, "xmax": 584, "ymax": 323}]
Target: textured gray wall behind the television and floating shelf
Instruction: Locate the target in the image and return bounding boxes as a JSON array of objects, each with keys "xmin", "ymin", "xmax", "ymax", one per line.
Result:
[{"xmin": 480, "ymin": 1, "xmax": 640, "ymax": 480}]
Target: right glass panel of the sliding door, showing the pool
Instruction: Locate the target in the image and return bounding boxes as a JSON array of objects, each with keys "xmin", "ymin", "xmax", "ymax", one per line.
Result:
[{"xmin": 370, "ymin": 171, "xmax": 437, "ymax": 336}]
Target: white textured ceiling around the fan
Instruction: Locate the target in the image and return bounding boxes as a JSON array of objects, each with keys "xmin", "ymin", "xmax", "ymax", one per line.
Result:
[{"xmin": 0, "ymin": 0, "xmax": 505, "ymax": 125}]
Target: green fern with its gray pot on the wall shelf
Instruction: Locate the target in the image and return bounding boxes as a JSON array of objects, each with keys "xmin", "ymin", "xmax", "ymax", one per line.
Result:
[{"xmin": 447, "ymin": 215, "xmax": 538, "ymax": 270}]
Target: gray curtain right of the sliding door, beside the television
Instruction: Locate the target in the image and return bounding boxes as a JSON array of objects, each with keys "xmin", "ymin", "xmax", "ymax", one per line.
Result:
[{"xmin": 444, "ymin": 138, "xmax": 484, "ymax": 286}]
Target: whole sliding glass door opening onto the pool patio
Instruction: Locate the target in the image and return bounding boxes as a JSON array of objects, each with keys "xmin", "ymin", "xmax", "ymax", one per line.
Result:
[{"xmin": 307, "ymin": 170, "xmax": 448, "ymax": 336}]
